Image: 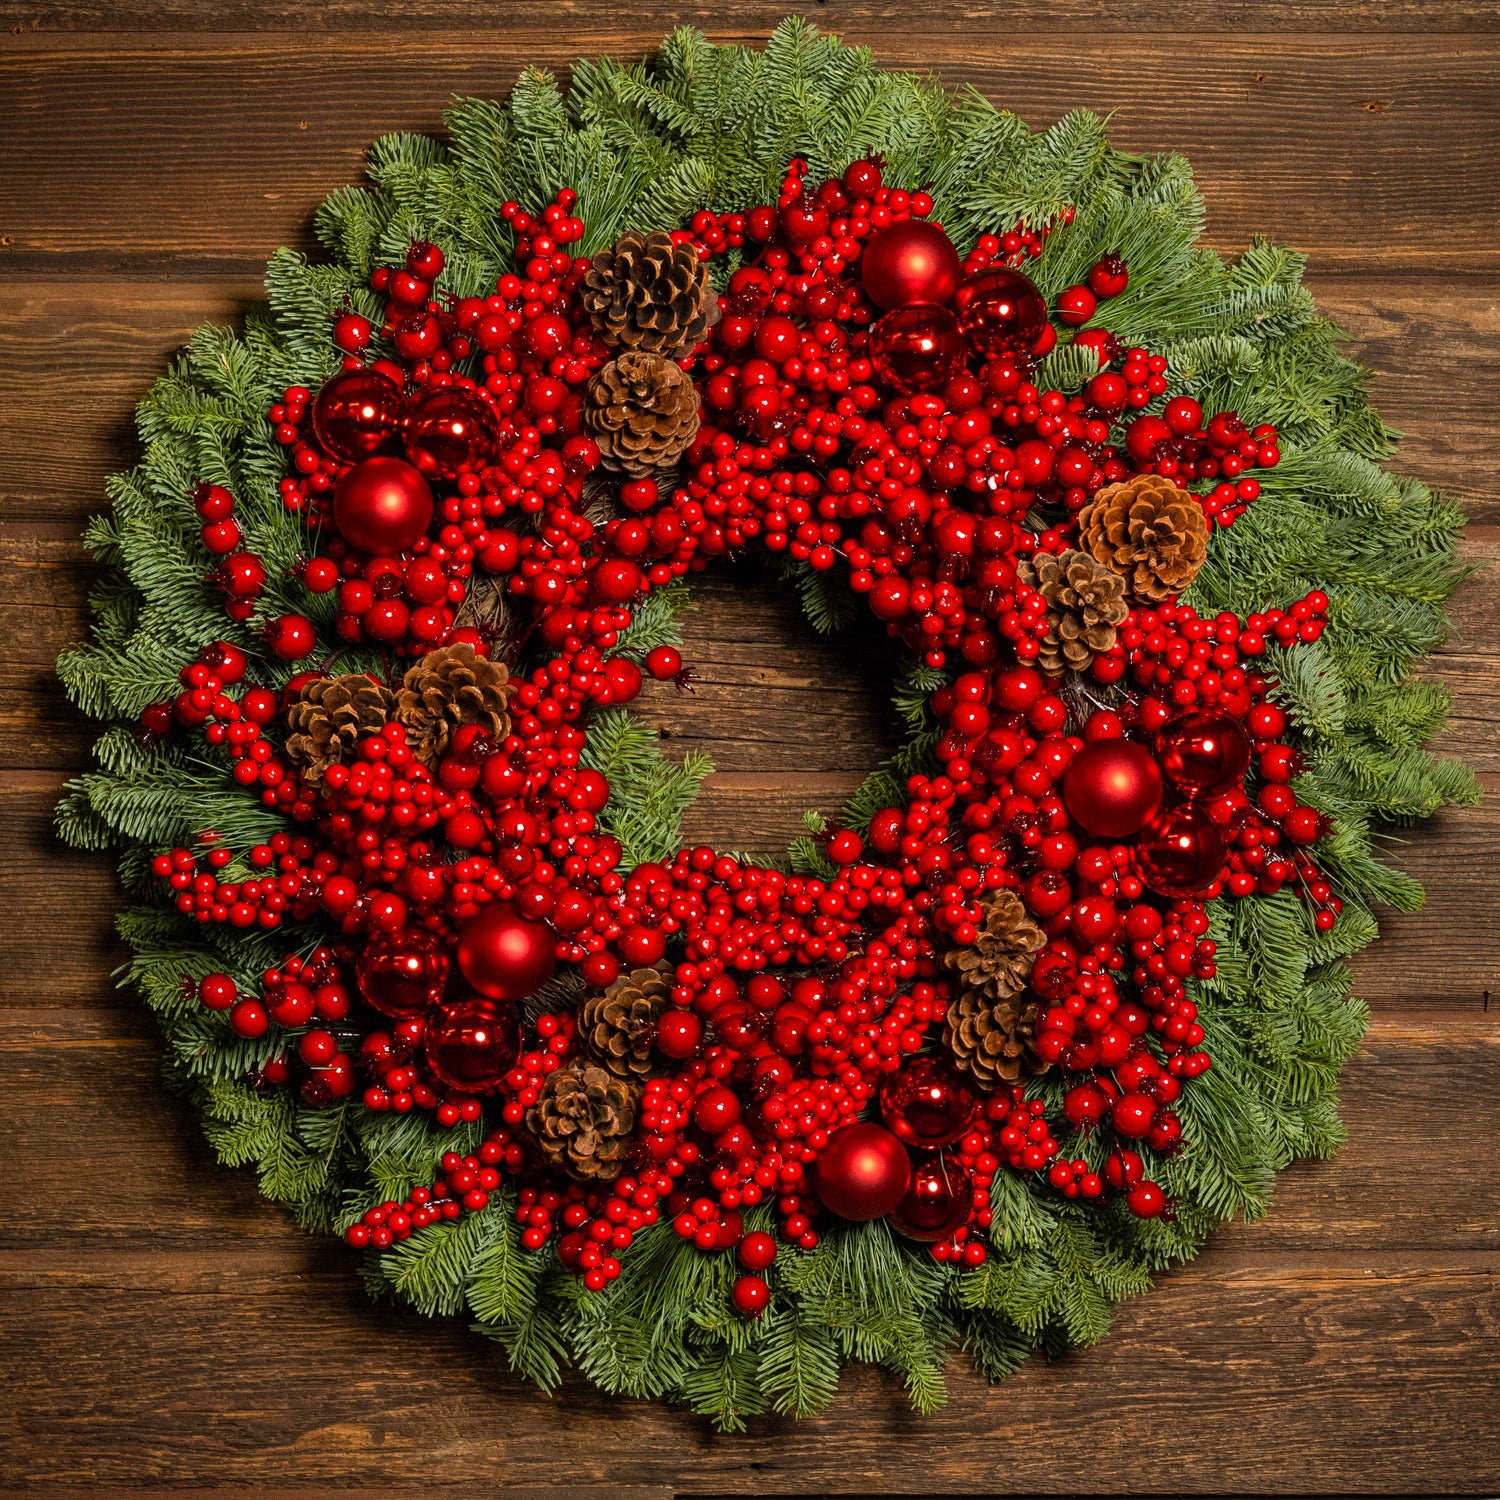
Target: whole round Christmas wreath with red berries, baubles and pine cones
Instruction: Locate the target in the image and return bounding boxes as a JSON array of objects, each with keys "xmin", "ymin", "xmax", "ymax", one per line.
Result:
[{"xmin": 59, "ymin": 21, "xmax": 1473, "ymax": 1427}]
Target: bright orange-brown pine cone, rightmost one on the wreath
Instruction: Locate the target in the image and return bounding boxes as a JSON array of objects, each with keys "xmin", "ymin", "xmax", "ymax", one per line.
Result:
[{"xmin": 1079, "ymin": 474, "xmax": 1209, "ymax": 605}]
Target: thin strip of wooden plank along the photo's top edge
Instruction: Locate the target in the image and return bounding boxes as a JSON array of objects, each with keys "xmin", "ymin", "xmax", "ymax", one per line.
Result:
[{"xmin": 0, "ymin": 0, "xmax": 1497, "ymax": 35}]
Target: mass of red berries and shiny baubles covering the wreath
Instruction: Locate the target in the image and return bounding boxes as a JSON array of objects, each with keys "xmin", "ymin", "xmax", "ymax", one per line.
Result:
[{"xmin": 144, "ymin": 162, "xmax": 1338, "ymax": 1316}]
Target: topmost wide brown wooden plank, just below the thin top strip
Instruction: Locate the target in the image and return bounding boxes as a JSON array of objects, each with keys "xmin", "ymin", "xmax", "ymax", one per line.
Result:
[{"xmin": 0, "ymin": 35, "xmax": 1500, "ymax": 275}]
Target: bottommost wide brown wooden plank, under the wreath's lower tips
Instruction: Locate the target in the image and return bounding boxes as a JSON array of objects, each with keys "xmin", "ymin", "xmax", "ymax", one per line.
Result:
[{"xmin": 0, "ymin": 1253, "xmax": 1500, "ymax": 1494}]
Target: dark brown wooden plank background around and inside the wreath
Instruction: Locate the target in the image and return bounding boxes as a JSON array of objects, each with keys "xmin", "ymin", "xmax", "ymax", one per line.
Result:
[{"xmin": 0, "ymin": 0, "xmax": 1500, "ymax": 1497}]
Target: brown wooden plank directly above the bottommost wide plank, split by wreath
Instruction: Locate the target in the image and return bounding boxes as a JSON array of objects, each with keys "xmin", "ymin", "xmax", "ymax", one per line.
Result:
[{"xmin": 0, "ymin": 1005, "xmax": 1500, "ymax": 1248}]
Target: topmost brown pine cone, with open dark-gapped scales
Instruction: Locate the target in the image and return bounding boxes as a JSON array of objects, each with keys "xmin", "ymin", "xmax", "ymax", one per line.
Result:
[{"xmin": 582, "ymin": 230, "xmax": 719, "ymax": 357}]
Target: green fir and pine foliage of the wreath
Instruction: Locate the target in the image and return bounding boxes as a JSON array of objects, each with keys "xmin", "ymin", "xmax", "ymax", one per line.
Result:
[{"xmin": 57, "ymin": 20, "xmax": 1476, "ymax": 1430}]
